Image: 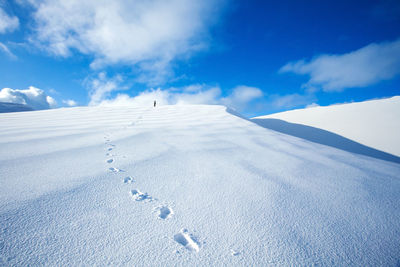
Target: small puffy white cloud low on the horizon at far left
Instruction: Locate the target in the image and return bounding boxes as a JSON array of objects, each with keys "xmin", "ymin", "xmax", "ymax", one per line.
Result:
[{"xmin": 0, "ymin": 86, "xmax": 57, "ymax": 110}]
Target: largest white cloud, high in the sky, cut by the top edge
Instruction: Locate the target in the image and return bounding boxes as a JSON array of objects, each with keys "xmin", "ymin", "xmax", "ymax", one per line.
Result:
[{"xmin": 22, "ymin": 0, "xmax": 225, "ymax": 84}]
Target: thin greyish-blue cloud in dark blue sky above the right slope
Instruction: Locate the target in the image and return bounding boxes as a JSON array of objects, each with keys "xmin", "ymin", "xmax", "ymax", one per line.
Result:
[{"xmin": 280, "ymin": 39, "xmax": 400, "ymax": 92}]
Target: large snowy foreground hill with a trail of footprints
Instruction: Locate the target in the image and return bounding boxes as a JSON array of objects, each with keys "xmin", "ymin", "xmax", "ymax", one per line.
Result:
[{"xmin": 0, "ymin": 106, "xmax": 400, "ymax": 266}]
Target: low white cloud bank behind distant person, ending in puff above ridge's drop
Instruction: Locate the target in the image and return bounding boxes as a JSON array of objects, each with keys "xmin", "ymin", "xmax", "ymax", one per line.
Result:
[{"xmin": 94, "ymin": 84, "xmax": 262, "ymax": 111}]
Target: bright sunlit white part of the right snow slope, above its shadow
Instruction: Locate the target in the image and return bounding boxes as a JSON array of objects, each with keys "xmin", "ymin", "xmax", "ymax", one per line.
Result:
[{"xmin": 254, "ymin": 96, "xmax": 400, "ymax": 157}]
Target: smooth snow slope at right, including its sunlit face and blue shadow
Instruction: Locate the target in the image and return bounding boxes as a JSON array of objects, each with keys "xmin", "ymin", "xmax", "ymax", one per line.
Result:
[{"xmin": 253, "ymin": 96, "xmax": 400, "ymax": 162}]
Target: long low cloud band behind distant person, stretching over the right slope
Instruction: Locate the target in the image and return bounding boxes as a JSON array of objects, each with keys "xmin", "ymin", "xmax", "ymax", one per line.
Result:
[{"xmin": 96, "ymin": 84, "xmax": 317, "ymax": 114}]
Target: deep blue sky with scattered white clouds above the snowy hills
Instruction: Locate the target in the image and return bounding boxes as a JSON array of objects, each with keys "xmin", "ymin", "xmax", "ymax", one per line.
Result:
[{"xmin": 0, "ymin": 0, "xmax": 400, "ymax": 117}]
